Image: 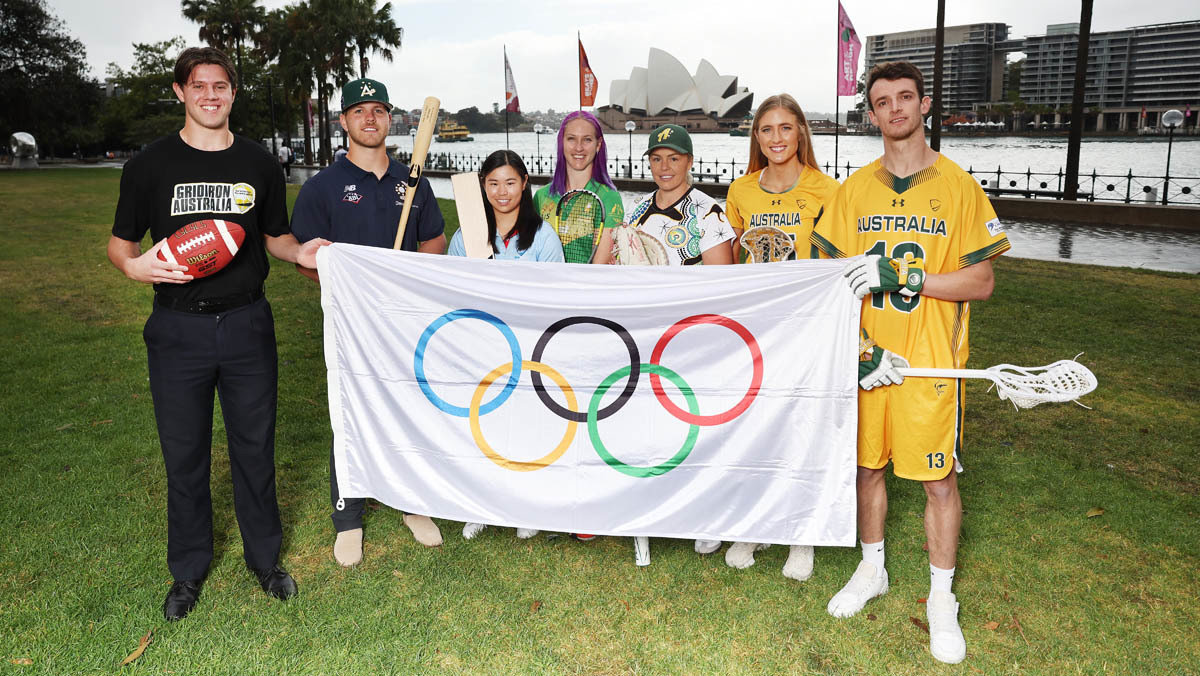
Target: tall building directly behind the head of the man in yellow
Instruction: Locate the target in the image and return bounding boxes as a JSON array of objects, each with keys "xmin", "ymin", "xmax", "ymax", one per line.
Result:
[{"xmin": 863, "ymin": 23, "xmax": 1008, "ymax": 113}]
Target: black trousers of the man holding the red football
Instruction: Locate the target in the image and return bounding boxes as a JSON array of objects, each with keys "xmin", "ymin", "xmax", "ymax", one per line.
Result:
[{"xmin": 143, "ymin": 298, "xmax": 283, "ymax": 580}]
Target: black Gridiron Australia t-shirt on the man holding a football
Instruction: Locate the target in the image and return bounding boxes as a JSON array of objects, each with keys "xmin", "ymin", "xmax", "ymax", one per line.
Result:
[{"xmin": 113, "ymin": 133, "xmax": 289, "ymax": 303}]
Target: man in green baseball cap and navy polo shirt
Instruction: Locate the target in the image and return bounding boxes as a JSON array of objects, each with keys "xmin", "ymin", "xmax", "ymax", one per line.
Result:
[{"xmin": 292, "ymin": 78, "xmax": 446, "ymax": 567}]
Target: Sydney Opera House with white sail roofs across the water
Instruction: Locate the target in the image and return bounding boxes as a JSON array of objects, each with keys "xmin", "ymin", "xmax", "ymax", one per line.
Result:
[{"xmin": 596, "ymin": 48, "xmax": 754, "ymax": 132}]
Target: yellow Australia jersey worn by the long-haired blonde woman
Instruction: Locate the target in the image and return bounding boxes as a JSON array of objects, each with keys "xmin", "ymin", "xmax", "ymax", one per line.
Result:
[{"xmin": 725, "ymin": 167, "xmax": 839, "ymax": 259}]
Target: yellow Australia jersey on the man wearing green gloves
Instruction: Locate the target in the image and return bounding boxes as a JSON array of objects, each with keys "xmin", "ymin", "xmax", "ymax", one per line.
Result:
[{"xmin": 811, "ymin": 155, "xmax": 1009, "ymax": 369}]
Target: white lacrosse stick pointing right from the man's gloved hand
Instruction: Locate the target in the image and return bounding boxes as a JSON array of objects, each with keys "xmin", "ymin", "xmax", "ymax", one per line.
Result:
[{"xmin": 896, "ymin": 359, "xmax": 1097, "ymax": 408}]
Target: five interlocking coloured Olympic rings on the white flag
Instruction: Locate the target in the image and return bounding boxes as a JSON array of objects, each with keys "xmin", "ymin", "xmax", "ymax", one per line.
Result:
[{"xmin": 413, "ymin": 310, "xmax": 763, "ymax": 478}]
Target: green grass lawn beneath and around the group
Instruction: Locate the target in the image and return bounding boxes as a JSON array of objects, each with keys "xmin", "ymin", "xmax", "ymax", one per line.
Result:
[{"xmin": 0, "ymin": 169, "xmax": 1200, "ymax": 675}]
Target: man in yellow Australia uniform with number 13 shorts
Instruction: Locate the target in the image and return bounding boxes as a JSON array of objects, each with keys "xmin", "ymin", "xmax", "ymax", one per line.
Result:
[{"xmin": 812, "ymin": 62, "xmax": 1009, "ymax": 664}]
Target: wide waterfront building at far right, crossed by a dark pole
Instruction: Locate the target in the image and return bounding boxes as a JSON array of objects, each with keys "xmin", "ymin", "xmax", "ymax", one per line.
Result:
[{"xmin": 1020, "ymin": 20, "xmax": 1200, "ymax": 131}]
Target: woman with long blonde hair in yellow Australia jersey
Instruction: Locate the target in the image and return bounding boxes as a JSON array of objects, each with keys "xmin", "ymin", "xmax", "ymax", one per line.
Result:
[{"xmin": 725, "ymin": 94, "xmax": 838, "ymax": 262}]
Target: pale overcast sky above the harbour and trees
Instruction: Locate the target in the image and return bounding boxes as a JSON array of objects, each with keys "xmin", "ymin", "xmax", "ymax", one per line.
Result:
[{"xmin": 48, "ymin": 0, "xmax": 1200, "ymax": 112}]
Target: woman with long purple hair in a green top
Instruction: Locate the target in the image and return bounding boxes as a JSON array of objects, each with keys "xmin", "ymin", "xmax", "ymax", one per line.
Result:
[{"xmin": 533, "ymin": 110, "xmax": 625, "ymax": 246}]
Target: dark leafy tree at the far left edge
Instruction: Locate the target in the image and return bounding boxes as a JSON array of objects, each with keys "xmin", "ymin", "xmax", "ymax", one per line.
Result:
[{"xmin": 0, "ymin": 0, "xmax": 101, "ymax": 155}]
